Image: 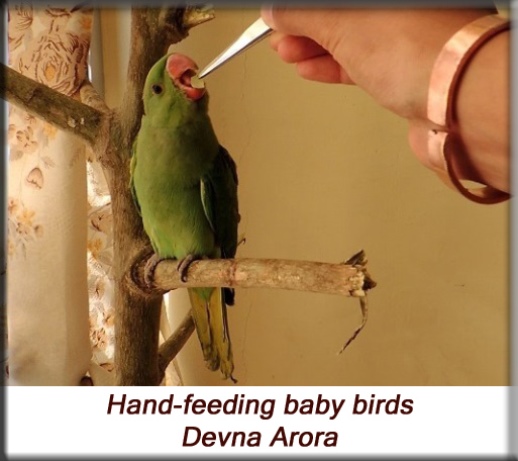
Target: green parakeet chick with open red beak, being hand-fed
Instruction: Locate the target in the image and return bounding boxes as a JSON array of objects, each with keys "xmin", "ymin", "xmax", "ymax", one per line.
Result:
[{"xmin": 131, "ymin": 54, "xmax": 239, "ymax": 380}]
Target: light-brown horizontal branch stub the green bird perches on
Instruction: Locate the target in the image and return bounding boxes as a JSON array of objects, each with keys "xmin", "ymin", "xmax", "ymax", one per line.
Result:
[{"xmin": 133, "ymin": 253, "xmax": 376, "ymax": 297}]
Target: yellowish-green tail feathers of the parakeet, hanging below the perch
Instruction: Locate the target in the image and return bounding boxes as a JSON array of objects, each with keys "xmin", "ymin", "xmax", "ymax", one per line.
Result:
[{"xmin": 187, "ymin": 288, "xmax": 234, "ymax": 380}]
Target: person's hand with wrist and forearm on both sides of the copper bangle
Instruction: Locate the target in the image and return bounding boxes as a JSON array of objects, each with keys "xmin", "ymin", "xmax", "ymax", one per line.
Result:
[{"xmin": 261, "ymin": 7, "xmax": 508, "ymax": 190}]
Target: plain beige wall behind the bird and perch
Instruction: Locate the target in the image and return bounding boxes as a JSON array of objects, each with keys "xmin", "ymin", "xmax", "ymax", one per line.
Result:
[{"xmin": 102, "ymin": 9, "xmax": 509, "ymax": 385}]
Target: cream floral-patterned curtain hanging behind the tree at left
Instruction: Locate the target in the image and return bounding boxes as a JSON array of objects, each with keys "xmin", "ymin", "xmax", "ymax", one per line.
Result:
[{"xmin": 7, "ymin": 4, "xmax": 113, "ymax": 385}]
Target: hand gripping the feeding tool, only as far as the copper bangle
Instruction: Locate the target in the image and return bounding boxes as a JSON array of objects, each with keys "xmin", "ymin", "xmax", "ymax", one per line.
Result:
[{"xmin": 261, "ymin": 8, "xmax": 494, "ymax": 119}]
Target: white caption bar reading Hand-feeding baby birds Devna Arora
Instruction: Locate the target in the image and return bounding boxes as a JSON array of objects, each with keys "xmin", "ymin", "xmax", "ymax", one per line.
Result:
[{"xmin": 6, "ymin": 386, "xmax": 509, "ymax": 456}]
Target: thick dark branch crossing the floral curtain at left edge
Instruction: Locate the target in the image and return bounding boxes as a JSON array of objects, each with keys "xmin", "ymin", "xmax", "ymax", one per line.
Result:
[{"xmin": 0, "ymin": 63, "xmax": 103, "ymax": 145}]
